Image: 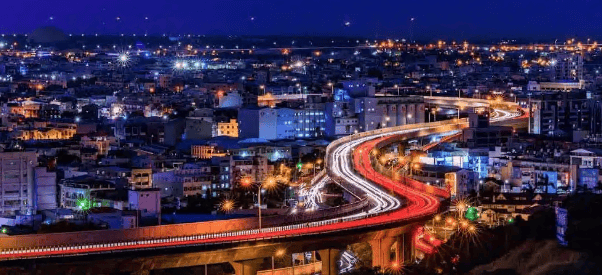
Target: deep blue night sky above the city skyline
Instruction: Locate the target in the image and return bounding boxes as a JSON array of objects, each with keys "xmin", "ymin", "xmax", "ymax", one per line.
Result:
[{"xmin": 0, "ymin": 0, "xmax": 602, "ymax": 39}]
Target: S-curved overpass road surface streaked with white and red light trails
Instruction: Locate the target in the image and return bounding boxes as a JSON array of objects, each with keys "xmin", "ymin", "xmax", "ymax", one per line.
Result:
[{"xmin": 0, "ymin": 98, "xmax": 516, "ymax": 260}]
